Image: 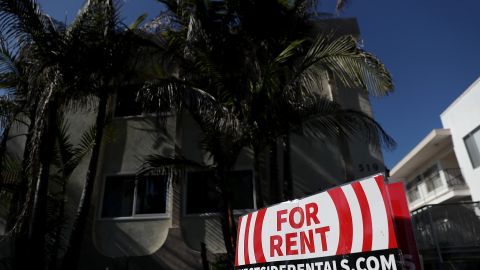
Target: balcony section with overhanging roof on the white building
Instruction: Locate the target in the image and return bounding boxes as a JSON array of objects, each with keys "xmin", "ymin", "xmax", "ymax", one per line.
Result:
[{"xmin": 390, "ymin": 129, "xmax": 470, "ymax": 211}]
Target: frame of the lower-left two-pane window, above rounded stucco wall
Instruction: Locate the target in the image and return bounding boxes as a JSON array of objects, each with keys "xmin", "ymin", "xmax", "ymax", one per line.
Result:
[{"xmin": 97, "ymin": 172, "xmax": 172, "ymax": 221}]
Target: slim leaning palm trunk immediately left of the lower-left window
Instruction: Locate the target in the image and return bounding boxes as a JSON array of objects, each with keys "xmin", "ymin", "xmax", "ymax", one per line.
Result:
[{"xmin": 62, "ymin": 92, "xmax": 108, "ymax": 270}]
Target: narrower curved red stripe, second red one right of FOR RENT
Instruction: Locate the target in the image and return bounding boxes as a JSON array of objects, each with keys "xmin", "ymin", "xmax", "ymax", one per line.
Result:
[{"xmin": 352, "ymin": 182, "xmax": 372, "ymax": 252}]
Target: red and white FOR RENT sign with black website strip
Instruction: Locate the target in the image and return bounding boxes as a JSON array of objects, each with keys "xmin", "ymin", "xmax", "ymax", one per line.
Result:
[{"xmin": 235, "ymin": 175, "xmax": 402, "ymax": 270}]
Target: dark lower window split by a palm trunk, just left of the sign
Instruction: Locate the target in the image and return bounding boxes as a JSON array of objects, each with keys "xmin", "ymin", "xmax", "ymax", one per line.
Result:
[{"xmin": 185, "ymin": 170, "xmax": 255, "ymax": 214}]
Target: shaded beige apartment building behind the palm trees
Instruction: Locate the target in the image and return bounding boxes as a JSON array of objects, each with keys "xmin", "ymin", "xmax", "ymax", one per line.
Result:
[{"xmin": 2, "ymin": 19, "xmax": 384, "ymax": 269}]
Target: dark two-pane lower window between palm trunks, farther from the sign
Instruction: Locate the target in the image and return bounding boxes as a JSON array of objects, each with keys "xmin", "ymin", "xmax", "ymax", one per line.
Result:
[{"xmin": 102, "ymin": 175, "xmax": 168, "ymax": 218}]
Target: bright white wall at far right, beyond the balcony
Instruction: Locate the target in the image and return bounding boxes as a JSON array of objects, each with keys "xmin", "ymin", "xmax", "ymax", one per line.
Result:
[{"xmin": 440, "ymin": 78, "xmax": 480, "ymax": 201}]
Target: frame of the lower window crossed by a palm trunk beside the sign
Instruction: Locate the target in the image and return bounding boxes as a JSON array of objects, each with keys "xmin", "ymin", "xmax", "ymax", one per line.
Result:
[{"xmin": 182, "ymin": 167, "xmax": 257, "ymax": 218}]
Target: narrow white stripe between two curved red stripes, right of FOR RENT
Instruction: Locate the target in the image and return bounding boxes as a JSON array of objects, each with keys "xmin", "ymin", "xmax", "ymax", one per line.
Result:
[{"xmin": 342, "ymin": 185, "xmax": 363, "ymax": 253}]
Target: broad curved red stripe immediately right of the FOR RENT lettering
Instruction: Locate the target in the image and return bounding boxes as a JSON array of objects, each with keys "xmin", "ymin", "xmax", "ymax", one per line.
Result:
[{"xmin": 328, "ymin": 188, "xmax": 353, "ymax": 255}]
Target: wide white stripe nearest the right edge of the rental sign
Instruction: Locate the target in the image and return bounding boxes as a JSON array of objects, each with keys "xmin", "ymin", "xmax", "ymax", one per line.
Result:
[{"xmin": 360, "ymin": 178, "xmax": 388, "ymax": 250}]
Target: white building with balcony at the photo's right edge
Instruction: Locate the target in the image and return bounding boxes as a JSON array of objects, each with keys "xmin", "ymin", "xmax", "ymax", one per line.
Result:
[{"xmin": 390, "ymin": 78, "xmax": 480, "ymax": 210}]
